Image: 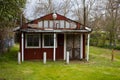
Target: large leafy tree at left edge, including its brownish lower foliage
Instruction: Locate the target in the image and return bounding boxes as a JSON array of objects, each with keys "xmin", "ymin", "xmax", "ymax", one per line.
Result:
[{"xmin": 0, "ymin": 0, "xmax": 25, "ymax": 52}]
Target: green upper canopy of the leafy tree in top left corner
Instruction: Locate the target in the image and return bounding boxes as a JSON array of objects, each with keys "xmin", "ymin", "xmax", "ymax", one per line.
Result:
[{"xmin": 0, "ymin": 0, "xmax": 25, "ymax": 24}]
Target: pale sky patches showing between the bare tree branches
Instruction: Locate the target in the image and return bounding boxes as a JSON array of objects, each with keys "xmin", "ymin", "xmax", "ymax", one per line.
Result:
[{"xmin": 23, "ymin": 0, "xmax": 105, "ymax": 20}]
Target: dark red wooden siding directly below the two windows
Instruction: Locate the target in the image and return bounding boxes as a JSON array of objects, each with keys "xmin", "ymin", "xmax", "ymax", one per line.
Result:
[{"xmin": 24, "ymin": 48, "xmax": 53, "ymax": 60}]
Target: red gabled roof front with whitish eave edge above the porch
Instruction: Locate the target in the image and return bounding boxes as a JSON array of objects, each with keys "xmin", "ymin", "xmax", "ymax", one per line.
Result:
[{"xmin": 19, "ymin": 13, "xmax": 91, "ymax": 32}]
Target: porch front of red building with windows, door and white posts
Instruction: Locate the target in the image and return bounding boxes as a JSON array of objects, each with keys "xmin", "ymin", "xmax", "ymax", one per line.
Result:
[{"xmin": 21, "ymin": 32, "xmax": 89, "ymax": 61}]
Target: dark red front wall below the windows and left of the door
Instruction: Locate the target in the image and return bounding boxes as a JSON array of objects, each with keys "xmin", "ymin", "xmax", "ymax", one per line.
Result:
[{"xmin": 24, "ymin": 34, "xmax": 64, "ymax": 60}]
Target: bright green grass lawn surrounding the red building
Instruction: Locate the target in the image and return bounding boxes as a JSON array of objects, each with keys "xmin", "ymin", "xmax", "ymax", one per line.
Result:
[{"xmin": 0, "ymin": 45, "xmax": 120, "ymax": 80}]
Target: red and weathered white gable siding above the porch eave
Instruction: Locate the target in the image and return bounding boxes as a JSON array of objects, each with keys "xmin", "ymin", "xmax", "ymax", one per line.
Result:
[{"xmin": 22, "ymin": 13, "xmax": 81, "ymax": 30}]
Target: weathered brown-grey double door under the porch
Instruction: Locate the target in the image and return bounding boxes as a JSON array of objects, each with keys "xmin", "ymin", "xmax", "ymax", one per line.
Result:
[{"xmin": 66, "ymin": 34, "xmax": 80, "ymax": 59}]
